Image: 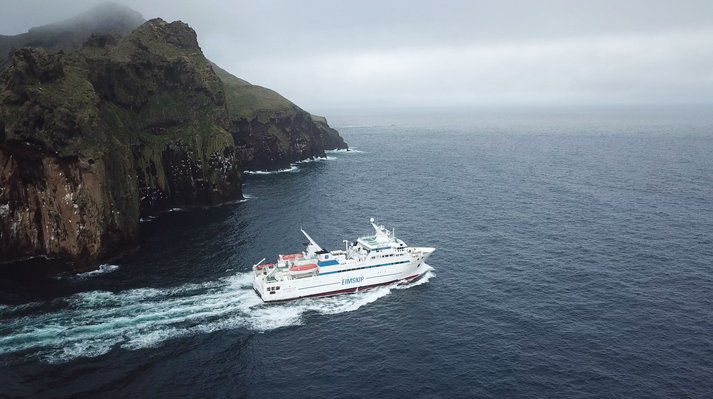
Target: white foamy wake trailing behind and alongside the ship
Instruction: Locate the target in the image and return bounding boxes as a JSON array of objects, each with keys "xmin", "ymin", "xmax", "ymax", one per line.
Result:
[{"xmin": 0, "ymin": 272, "xmax": 433, "ymax": 363}]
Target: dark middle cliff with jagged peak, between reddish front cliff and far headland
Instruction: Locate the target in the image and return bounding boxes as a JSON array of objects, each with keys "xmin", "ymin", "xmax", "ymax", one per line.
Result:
[{"xmin": 83, "ymin": 20, "xmax": 241, "ymax": 214}]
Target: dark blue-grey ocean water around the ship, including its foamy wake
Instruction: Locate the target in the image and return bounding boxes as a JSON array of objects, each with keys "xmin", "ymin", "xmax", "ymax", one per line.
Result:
[{"xmin": 0, "ymin": 108, "xmax": 713, "ymax": 398}]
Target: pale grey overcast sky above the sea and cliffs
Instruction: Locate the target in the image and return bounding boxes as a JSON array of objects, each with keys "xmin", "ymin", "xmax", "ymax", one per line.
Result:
[{"xmin": 0, "ymin": 0, "xmax": 713, "ymax": 111}]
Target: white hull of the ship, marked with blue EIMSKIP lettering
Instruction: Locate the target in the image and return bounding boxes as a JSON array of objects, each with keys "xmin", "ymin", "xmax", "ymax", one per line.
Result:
[{"xmin": 253, "ymin": 248, "xmax": 434, "ymax": 302}]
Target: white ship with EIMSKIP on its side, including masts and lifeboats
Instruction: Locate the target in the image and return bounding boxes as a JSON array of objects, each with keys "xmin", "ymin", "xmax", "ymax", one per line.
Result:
[{"xmin": 253, "ymin": 218, "xmax": 436, "ymax": 302}]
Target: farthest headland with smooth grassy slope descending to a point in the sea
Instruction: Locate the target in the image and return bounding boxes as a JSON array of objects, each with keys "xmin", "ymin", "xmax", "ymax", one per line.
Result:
[{"xmin": 213, "ymin": 65, "xmax": 348, "ymax": 170}]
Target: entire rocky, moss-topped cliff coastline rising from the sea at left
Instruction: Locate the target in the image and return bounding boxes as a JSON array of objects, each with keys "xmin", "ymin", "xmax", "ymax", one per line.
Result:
[{"xmin": 0, "ymin": 13, "xmax": 346, "ymax": 269}]
